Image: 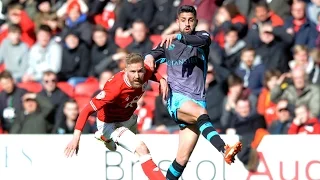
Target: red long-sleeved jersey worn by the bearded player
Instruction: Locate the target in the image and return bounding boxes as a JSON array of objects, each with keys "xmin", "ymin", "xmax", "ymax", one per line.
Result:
[{"xmin": 75, "ymin": 65, "xmax": 162, "ymax": 130}]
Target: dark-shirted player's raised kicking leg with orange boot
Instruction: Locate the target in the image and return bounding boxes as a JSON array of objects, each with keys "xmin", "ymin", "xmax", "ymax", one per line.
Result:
[{"xmin": 177, "ymin": 100, "xmax": 242, "ymax": 164}]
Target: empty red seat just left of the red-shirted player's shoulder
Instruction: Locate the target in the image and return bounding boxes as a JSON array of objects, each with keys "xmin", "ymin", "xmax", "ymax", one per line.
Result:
[{"xmin": 74, "ymin": 82, "xmax": 99, "ymax": 97}]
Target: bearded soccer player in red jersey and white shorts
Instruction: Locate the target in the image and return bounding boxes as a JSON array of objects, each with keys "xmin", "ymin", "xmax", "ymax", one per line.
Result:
[{"xmin": 65, "ymin": 53, "xmax": 168, "ymax": 180}]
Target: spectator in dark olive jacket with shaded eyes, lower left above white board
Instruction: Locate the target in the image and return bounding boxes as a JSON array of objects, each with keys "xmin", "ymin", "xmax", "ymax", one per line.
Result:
[{"xmin": 9, "ymin": 93, "xmax": 53, "ymax": 134}]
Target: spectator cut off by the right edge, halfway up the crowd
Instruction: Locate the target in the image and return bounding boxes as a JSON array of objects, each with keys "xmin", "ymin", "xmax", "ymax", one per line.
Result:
[{"xmin": 309, "ymin": 48, "xmax": 320, "ymax": 85}]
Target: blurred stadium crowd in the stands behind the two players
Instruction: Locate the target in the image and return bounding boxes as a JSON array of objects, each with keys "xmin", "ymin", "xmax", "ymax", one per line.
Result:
[{"xmin": 0, "ymin": 0, "xmax": 320, "ymax": 170}]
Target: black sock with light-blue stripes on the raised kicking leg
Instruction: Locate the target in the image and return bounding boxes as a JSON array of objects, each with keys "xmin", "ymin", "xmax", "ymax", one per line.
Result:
[{"xmin": 197, "ymin": 114, "xmax": 225, "ymax": 152}]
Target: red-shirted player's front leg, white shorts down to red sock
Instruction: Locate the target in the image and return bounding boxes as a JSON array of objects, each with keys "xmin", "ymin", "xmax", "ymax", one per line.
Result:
[{"xmin": 111, "ymin": 127, "xmax": 165, "ymax": 180}]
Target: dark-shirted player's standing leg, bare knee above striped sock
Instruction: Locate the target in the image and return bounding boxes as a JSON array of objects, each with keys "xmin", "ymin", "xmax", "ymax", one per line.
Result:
[{"xmin": 166, "ymin": 125, "xmax": 199, "ymax": 180}]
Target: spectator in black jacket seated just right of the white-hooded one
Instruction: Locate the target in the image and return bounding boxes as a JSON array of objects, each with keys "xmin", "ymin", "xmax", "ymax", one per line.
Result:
[{"xmin": 58, "ymin": 31, "xmax": 90, "ymax": 86}]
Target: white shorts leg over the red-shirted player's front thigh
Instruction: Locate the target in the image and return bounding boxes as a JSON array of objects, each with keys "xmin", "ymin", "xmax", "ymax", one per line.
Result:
[{"xmin": 111, "ymin": 127, "xmax": 141, "ymax": 153}]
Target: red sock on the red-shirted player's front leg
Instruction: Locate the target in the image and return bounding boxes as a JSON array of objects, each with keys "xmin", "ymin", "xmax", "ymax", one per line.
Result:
[{"xmin": 140, "ymin": 156, "xmax": 166, "ymax": 180}]
